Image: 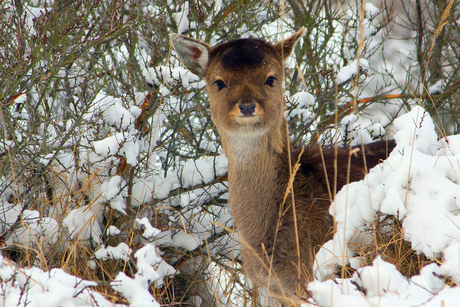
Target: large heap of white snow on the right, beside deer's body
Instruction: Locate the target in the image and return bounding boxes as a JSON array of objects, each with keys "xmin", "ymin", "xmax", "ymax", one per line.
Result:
[{"xmin": 309, "ymin": 106, "xmax": 460, "ymax": 306}]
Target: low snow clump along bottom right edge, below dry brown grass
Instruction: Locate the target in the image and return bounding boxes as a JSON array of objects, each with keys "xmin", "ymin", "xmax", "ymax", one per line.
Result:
[{"xmin": 308, "ymin": 257, "xmax": 459, "ymax": 307}]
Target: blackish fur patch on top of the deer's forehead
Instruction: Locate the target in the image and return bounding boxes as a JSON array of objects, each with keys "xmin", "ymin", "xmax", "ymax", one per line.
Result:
[{"xmin": 211, "ymin": 38, "xmax": 271, "ymax": 69}]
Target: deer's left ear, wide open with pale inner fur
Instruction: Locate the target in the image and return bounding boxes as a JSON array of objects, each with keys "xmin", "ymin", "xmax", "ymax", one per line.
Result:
[{"xmin": 170, "ymin": 33, "xmax": 212, "ymax": 78}]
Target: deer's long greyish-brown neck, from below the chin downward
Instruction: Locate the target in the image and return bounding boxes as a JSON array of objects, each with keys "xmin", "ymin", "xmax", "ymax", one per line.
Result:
[{"xmin": 222, "ymin": 127, "xmax": 287, "ymax": 244}]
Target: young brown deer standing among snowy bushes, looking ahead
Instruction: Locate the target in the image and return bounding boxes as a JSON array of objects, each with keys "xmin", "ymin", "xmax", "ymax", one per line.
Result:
[{"xmin": 171, "ymin": 28, "xmax": 394, "ymax": 303}]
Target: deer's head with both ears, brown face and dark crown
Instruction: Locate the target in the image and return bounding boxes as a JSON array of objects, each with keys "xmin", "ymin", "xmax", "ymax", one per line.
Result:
[{"xmin": 171, "ymin": 28, "xmax": 304, "ymax": 154}]
